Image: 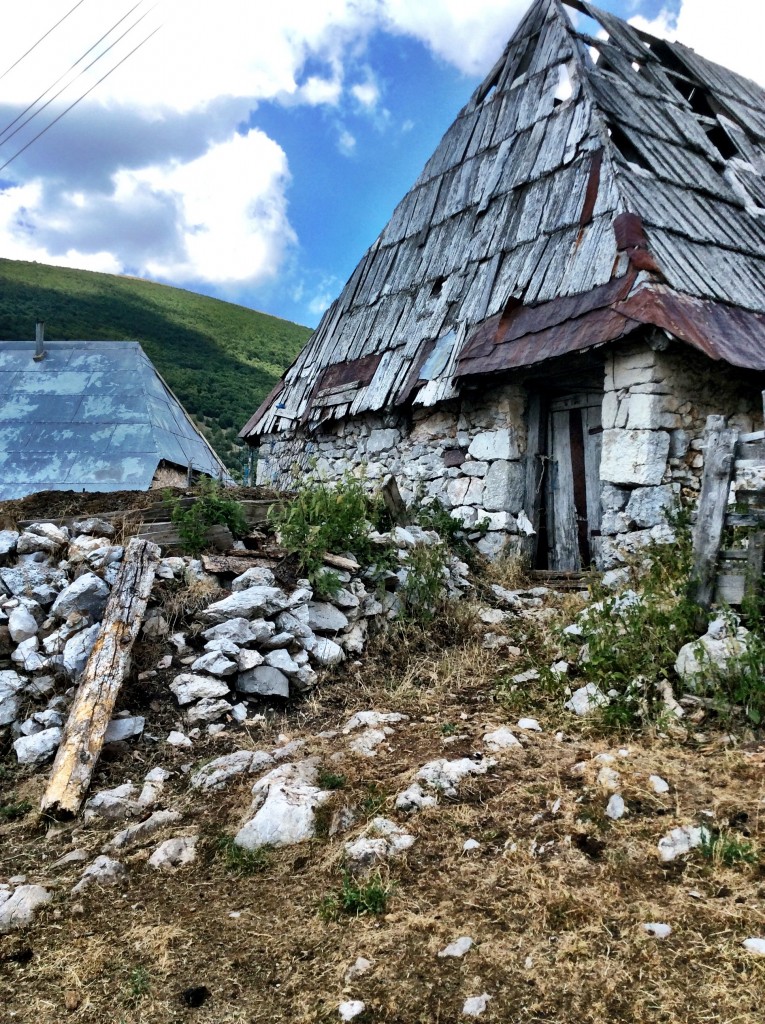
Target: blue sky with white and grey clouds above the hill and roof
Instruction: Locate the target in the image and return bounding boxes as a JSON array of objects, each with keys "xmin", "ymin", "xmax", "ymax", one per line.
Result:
[{"xmin": 0, "ymin": 0, "xmax": 765, "ymax": 325}]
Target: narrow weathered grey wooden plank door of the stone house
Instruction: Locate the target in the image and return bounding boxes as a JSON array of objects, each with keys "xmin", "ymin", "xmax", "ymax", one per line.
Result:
[{"xmin": 545, "ymin": 391, "xmax": 603, "ymax": 571}]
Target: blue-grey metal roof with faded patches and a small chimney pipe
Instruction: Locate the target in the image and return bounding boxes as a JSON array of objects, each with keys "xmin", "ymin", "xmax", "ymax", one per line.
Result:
[{"xmin": 0, "ymin": 341, "xmax": 225, "ymax": 500}]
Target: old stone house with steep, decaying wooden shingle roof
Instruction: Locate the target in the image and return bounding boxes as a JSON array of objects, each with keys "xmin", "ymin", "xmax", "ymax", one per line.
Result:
[{"xmin": 241, "ymin": 0, "xmax": 765, "ymax": 570}]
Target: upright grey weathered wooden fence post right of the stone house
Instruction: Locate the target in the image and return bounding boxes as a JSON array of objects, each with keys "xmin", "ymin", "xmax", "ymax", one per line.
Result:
[{"xmin": 690, "ymin": 416, "xmax": 738, "ymax": 628}]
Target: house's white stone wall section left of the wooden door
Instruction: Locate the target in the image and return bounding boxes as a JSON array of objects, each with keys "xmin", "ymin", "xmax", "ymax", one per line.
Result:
[{"xmin": 257, "ymin": 385, "xmax": 526, "ymax": 556}]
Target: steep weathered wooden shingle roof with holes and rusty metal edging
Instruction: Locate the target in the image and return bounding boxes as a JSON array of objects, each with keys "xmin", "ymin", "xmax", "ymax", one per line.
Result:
[{"xmin": 242, "ymin": 0, "xmax": 765, "ymax": 437}]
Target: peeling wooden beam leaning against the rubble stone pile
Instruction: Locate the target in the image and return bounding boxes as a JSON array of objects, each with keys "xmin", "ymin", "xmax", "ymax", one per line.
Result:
[{"xmin": 41, "ymin": 538, "xmax": 160, "ymax": 817}]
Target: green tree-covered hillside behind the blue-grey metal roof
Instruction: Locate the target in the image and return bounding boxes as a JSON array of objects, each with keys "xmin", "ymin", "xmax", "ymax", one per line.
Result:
[{"xmin": 0, "ymin": 259, "xmax": 310, "ymax": 470}]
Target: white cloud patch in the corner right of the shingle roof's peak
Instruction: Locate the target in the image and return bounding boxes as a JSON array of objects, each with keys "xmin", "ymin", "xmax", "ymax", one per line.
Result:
[{"xmin": 630, "ymin": 0, "xmax": 765, "ymax": 84}]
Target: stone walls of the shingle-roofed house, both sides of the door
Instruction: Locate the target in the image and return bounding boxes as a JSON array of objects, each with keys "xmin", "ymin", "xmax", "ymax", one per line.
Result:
[{"xmin": 257, "ymin": 340, "xmax": 765, "ymax": 567}]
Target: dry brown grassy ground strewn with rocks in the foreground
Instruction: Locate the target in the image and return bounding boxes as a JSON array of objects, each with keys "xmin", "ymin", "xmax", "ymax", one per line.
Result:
[{"xmin": 0, "ymin": 598, "xmax": 765, "ymax": 1024}]
